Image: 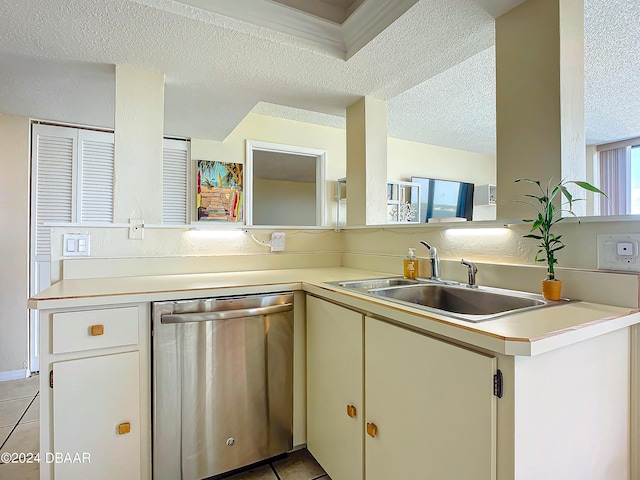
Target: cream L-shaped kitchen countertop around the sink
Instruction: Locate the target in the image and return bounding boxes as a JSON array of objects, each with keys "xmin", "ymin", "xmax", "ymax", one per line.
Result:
[{"xmin": 29, "ymin": 267, "xmax": 640, "ymax": 356}]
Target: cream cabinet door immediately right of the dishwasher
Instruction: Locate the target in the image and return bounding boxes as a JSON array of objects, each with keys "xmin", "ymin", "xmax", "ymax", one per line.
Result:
[{"xmin": 307, "ymin": 296, "xmax": 362, "ymax": 480}]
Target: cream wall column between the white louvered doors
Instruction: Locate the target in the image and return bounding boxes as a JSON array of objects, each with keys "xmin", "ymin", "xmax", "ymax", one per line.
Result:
[{"xmin": 113, "ymin": 65, "xmax": 164, "ymax": 223}]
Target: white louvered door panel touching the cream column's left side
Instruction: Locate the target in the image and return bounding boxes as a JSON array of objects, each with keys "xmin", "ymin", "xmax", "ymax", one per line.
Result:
[{"xmin": 78, "ymin": 130, "xmax": 114, "ymax": 223}]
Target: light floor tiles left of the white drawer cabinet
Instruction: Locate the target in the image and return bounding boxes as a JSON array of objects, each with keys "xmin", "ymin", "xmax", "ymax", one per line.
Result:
[{"xmin": 0, "ymin": 375, "xmax": 40, "ymax": 480}]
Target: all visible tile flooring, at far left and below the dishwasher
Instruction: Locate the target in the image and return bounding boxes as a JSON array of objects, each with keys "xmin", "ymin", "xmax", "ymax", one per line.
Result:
[{"xmin": 0, "ymin": 375, "xmax": 331, "ymax": 480}]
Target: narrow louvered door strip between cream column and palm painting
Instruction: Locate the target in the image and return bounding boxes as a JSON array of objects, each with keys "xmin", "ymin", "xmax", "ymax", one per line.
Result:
[{"xmin": 162, "ymin": 139, "xmax": 189, "ymax": 225}]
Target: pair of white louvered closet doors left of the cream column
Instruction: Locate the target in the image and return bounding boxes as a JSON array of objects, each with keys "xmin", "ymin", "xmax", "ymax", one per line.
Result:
[{"xmin": 29, "ymin": 125, "xmax": 114, "ymax": 371}]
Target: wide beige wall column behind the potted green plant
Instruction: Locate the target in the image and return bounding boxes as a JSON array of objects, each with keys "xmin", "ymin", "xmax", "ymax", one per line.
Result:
[{"xmin": 496, "ymin": 0, "xmax": 586, "ymax": 219}]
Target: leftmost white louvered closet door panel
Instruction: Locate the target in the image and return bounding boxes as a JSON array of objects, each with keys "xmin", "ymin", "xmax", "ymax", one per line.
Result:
[{"xmin": 34, "ymin": 127, "xmax": 76, "ymax": 255}]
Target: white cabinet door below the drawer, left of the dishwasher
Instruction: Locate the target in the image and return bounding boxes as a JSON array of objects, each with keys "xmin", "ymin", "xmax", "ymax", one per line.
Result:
[{"xmin": 51, "ymin": 352, "xmax": 140, "ymax": 480}]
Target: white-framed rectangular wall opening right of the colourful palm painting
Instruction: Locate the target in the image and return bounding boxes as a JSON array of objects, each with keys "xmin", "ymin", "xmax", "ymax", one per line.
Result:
[{"xmin": 245, "ymin": 140, "xmax": 326, "ymax": 227}]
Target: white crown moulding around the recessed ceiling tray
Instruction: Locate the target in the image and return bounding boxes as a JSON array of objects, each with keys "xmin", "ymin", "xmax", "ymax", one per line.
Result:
[{"xmin": 170, "ymin": 0, "xmax": 418, "ymax": 60}]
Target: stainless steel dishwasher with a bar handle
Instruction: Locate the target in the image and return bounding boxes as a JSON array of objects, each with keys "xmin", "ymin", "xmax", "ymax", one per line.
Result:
[{"xmin": 152, "ymin": 292, "xmax": 293, "ymax": 480}]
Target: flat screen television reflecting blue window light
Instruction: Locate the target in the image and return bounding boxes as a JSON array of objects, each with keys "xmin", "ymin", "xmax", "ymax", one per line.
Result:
[{"xmin": 411, "ymin": 177, "xmax": 473, "ymax": 223}]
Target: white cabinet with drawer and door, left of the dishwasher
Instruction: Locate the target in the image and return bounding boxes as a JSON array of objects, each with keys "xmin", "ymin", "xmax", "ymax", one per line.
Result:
[{"xmin": 40, "ymin": 304, "xmax": 151, "ymax": 480}]
